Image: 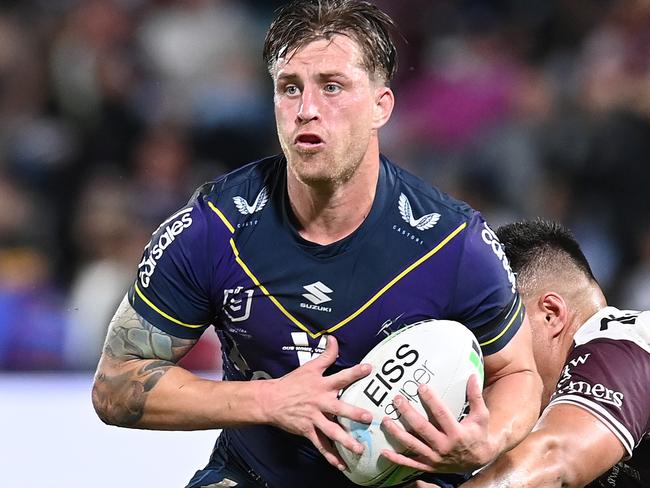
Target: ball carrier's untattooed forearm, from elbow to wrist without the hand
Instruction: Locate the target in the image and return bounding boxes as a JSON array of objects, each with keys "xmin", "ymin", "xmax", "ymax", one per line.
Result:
[{"xmin": 484, "ymin": 370, "xmax": 542, "ymax": 455}]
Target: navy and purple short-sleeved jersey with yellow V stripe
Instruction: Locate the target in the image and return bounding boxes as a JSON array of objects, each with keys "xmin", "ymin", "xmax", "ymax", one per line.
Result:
[{"xmin": 129, "ymin": 156, "xmax": 524, "ymax": 488}]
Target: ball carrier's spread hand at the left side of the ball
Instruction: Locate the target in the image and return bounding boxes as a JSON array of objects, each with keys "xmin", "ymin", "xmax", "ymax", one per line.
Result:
[{"xmin": 256, "ymin": 336, "xmax": 372, "ymax": 470}]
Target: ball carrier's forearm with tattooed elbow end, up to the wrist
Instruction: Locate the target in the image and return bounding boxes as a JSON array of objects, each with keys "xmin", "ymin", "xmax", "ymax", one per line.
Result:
[{"xmin": 93, "ymin": 357, "xmax": 265, "ymax": 430}]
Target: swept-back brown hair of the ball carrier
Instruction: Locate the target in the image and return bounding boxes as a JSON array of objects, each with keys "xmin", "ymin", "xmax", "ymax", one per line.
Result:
[{"xmin": 263, "ymin": 0, "xmax": 397, "ymax": 83}]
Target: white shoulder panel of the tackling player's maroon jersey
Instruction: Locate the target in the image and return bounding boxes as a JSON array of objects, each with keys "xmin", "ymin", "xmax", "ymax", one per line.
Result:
[{"xmin": 574, "ymin": 306, "xmax": 650, "ymax": 353}]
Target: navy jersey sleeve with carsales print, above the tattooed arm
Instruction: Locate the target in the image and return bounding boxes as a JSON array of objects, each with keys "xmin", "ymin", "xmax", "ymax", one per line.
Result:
[{"xmin": 128, "ymin": 192, "xmax": 227, "ymax": 339}]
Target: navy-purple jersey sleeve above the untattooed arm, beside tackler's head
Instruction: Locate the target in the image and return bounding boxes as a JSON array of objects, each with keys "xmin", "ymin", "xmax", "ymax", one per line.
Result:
[{"xmin": 452, "ymin": 213, "xmax": 524, "ymax": 355}]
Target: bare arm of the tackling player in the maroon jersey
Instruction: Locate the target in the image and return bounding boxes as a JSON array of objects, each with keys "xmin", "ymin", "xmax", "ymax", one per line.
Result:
[{"xmin": 462, "ymin": 404, "xmax": 625, "ymax": 488}]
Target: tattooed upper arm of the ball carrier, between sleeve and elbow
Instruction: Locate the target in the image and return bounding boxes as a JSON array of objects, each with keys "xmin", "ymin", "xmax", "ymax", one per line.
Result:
[{"xmin": 103, "ymin": 297, "xmax": 198, "ymax": 363}]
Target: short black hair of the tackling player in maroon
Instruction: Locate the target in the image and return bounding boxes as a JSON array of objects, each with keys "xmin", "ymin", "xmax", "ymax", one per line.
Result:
[{"xmin": 496, "ymin": 219, "xmax": 597, "ymax": 294}]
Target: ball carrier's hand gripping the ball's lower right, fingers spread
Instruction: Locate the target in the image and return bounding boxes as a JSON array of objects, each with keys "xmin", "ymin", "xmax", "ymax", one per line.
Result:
[{"xmin": 382, "ymin": 375, "xmax": 496, "ymax": 472}]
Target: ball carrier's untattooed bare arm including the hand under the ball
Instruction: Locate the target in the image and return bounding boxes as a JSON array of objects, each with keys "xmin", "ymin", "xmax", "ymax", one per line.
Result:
[{"xmin": 382, "ymin": 318, "xmax": 542, "ymax": 472}]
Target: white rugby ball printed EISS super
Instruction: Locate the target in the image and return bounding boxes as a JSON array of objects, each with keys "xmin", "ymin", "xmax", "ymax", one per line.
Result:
[{"xmin": 336, "ymin": 319, "xmax": 483, "ymax": 487}]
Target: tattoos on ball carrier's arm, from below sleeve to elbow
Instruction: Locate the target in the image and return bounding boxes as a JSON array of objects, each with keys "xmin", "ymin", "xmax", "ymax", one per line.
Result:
[{"xmin": 93, "ymin": 297, "xmax": 197, "ymax": 426}]
